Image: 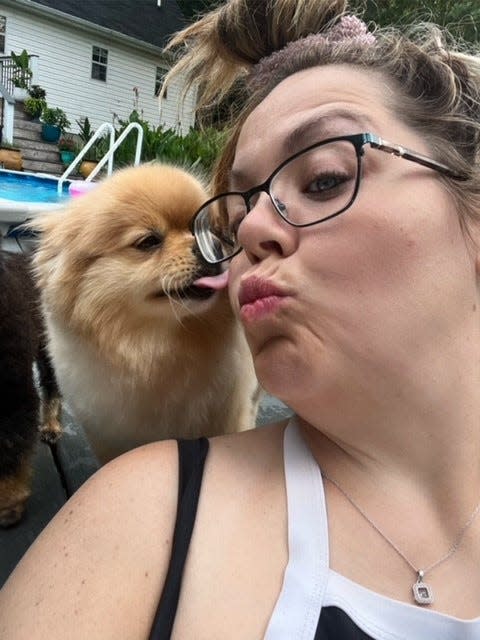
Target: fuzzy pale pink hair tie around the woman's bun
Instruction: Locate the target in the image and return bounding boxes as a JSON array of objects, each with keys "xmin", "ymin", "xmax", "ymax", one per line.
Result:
[{"xmin": 248, "ymin": 15, "xmax": 376, "ymax": 90}]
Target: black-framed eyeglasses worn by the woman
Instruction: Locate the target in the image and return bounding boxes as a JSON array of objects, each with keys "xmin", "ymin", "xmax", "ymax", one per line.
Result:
[{"xmin": 193, "ymin": 133, "xmax": 465, "ymax": 264}]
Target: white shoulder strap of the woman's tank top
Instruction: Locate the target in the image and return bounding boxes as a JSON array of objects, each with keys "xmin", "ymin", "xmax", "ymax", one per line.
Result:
[{"xmin": 265, "ymin": 418, "xmax": 329, "ymax": 640}]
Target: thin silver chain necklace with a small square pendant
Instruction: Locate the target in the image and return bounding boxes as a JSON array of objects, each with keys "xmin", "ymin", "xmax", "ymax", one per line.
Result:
[{"xmin": 322, "ymin": 471, "xmax": 480, "ymax": 605}]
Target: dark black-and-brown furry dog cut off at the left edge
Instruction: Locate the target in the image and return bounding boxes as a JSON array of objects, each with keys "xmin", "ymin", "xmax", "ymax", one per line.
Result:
[{"xmin": 0, "ymin": 251, "xmax": 61, "ymax": 527}]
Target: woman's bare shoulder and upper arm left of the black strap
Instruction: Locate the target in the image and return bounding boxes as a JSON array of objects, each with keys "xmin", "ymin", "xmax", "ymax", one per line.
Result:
[{"xmin": 0, "ymin": 441, "xmax": 178, "ymax": 640}]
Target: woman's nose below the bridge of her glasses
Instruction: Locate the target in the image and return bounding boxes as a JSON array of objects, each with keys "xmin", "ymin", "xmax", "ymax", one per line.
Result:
[{"xmin": 238, "ymin": 192, "xmax": 298, "ymax": 262}]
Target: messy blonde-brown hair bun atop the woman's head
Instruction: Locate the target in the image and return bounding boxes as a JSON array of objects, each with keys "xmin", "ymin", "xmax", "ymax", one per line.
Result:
[{"xmin": 166, "ymin": 0, "xmax": 348, "ymax": 107}]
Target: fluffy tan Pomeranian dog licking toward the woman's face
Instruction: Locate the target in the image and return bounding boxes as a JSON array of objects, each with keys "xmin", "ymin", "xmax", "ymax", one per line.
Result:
[{"xmin": 33, "ymin": 163, "xmax": 258, "ymax": 464}]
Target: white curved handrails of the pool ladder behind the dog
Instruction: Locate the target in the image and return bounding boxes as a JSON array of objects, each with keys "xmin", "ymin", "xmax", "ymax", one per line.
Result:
[{"xmin": 57, "ymin": 122, "xmax": 143, "ymax": 195}]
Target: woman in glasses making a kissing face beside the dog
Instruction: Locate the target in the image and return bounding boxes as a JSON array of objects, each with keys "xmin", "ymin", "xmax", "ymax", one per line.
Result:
[{"xmin": 0, "ymin": 0, "xmax": 480, "ymax": 640}]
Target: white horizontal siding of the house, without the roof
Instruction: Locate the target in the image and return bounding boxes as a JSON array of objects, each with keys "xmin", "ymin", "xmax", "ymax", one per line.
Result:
[{"xmin": 0, "ymin": 1, "xmax": 195, "ymax": 133}]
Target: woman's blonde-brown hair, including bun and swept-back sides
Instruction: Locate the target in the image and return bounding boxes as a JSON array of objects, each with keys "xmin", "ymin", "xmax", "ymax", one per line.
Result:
[{"xmin": 167, "ymin": 0, "xmax": 480, "ymax": 225}]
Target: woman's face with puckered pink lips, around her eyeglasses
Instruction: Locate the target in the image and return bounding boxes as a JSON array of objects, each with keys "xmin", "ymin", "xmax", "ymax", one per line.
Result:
[{"xmin": 230, "ymin": 66, "xmax": 478, "ymax": 416}]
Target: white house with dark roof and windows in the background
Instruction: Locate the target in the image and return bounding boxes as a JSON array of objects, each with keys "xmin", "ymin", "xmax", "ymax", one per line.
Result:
[{"xmin": 0, "ymin": 0, "xmax": 194, "ymax": 141}]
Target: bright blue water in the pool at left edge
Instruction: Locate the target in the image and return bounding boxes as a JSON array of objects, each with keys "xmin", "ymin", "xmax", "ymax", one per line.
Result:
[{"xmin": 0, "ymin": 169, "xmax": 70, "ymax": 203}]
